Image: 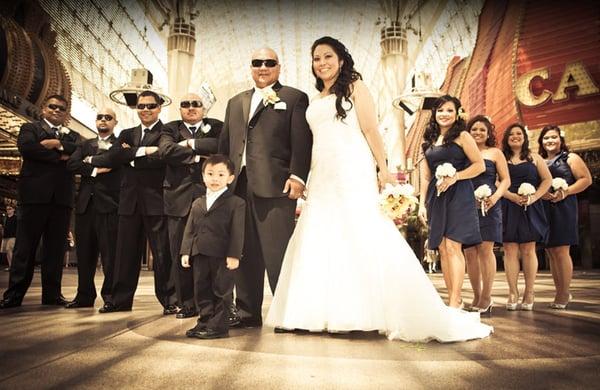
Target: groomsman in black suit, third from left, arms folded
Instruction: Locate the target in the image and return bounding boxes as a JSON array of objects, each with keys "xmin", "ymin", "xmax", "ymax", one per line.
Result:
[{"xmin": 85, "ymin": 91, "xmax": 177, "ymax": 314}]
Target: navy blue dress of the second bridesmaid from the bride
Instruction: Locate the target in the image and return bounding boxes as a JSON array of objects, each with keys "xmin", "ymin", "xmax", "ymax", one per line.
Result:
[{"xmin": 471, "ymin": 160, "xmax": 502, "ymax": 243}]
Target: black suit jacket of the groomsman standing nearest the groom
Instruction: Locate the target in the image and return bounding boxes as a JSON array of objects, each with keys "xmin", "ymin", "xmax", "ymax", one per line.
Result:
[{"xmin": 159, "ymin": 118, "xmax": 223, "ymax": 217}]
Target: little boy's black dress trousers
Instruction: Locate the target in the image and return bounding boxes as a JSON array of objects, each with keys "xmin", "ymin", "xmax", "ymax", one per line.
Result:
[{"xmin": 195, "ymin": 255, "xmax": 235, "ymax": 331}]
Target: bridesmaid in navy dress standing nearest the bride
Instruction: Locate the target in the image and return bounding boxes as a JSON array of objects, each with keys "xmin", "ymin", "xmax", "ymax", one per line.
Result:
[{"xmin": 419, "ymin": 95, "xmax": 485, "ymax": 308}]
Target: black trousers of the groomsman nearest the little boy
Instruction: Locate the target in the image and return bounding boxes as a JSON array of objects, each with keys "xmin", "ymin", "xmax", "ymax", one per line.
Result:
[{"xmin": 167, "ymin": 216, "xmax": 196, "ymax": 310}]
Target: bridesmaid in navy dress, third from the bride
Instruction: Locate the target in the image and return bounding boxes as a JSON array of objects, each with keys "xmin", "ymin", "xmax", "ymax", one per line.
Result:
[{"xmin": 502, "ymin": 123, "xmax": 552, "ymax": 310}]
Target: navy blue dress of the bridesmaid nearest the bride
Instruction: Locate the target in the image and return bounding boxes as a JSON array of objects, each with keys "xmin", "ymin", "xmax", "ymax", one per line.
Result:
[{"xmin": 425, "ymin": 142, "xmax": 481, "ymax": 249}]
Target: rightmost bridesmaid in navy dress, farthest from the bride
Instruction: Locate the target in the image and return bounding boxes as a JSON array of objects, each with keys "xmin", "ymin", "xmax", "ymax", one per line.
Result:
[{"xmin": 538, "ymin": 125, "xmax": 592, "ymax": 310}]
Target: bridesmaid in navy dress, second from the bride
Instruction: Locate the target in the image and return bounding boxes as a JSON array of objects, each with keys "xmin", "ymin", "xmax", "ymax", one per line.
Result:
[{"xmin": 465, "ymin": 115, "xmax": 510, "ymax": 314}]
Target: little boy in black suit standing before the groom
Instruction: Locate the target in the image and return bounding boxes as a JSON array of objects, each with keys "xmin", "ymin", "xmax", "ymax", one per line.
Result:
[{"xmin": 181, "ymin": 154, "xmax": 246, "ymax": 339}]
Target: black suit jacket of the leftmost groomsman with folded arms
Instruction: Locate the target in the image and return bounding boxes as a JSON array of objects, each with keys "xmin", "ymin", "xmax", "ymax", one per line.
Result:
[{"xmin": 17, "ymin": 121, "xmax": 80, "ymax": 207}]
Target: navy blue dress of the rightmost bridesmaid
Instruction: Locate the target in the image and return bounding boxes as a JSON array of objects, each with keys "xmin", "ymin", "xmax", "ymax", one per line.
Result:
[{"xmin": 543, "ymin": 152, "xmax": 579, "ymax": 247}]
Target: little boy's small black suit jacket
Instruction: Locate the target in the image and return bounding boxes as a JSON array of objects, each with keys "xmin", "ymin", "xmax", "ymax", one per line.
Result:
[{"xmin": 180, "ymin": 191, "xmax": 246, "ymax": 259}]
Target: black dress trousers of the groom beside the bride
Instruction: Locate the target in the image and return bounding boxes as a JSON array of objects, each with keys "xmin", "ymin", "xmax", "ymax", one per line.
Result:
[{"xmin": 235, "ymin": 168, "xmax": 296, "ymax": 321}]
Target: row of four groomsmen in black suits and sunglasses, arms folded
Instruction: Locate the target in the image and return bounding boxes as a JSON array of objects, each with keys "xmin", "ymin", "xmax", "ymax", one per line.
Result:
[{"xmin": 0, "ymin": 90, "xmax": 223, "ymax": 318}]
